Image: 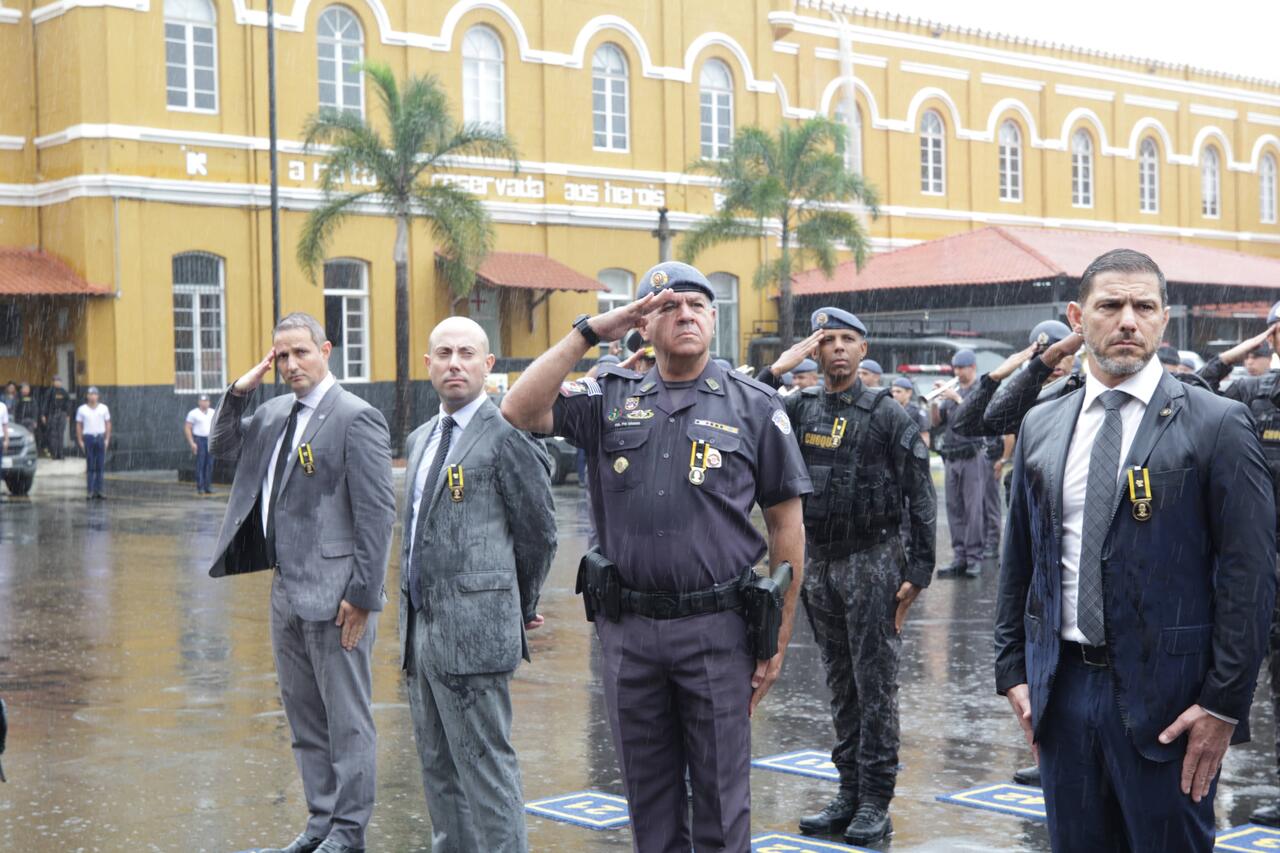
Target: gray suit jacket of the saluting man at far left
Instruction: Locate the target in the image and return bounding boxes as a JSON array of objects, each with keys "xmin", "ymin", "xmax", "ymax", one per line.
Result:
[{"xmin": 209, "ymin": 384, "xmax": 396, "ymax": 621}]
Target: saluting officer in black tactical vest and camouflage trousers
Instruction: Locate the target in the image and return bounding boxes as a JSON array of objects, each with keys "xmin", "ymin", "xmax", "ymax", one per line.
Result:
[{"xmin": 769, "ymin": 307, "xmax": 937, "ymax": 844}]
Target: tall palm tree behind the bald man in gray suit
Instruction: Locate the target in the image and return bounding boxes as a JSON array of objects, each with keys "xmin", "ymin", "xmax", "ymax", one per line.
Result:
[{"xmin": 297, "ymin": 63, "xmax": 518, "ymax": 453}]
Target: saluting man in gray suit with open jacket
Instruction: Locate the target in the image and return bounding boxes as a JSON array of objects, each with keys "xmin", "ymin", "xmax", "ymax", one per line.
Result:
[{"xmin": 209, "ymin": 314, "xmax": 396, "ymax": 853}]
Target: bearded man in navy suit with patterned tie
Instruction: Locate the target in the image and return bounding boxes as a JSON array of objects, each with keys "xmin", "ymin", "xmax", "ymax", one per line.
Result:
[{"xmin": 996, "ymin": 250, "xmax": 1275, "ymax": 853}]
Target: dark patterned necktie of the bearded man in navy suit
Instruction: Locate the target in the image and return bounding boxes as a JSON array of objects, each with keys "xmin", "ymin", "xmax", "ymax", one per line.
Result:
[{"xmin": 1075, "ymin": 391, "xmax": 1129, "ymax": 646}]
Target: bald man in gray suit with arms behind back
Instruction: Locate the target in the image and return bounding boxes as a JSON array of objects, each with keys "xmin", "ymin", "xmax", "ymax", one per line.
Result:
[{"xmin": 399, "ymin": 316, "xmax": 556, "ymax": 853}]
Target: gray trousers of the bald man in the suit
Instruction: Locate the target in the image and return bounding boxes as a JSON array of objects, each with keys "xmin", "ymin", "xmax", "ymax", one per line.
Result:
[{"xmin": 408, "ymin": 611, "xmax": 529, "ymax": 853}]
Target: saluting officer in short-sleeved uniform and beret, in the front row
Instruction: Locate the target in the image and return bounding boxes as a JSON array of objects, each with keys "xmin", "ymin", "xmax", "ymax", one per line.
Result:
[{"xmin": 502, "ymin": 261, "xmax": 810, "ymax": 853}]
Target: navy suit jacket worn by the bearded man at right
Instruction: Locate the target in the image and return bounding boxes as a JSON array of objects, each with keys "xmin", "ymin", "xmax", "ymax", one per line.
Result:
[{"xmin": 996, "ymin": 374, "xmax": 1276, "ymax": 761}]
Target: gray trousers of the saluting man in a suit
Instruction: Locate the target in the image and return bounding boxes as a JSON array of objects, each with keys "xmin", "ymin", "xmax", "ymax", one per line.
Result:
[{"xmin": 271, "ymin": 571, "xmax": 378, "ymax": 849}]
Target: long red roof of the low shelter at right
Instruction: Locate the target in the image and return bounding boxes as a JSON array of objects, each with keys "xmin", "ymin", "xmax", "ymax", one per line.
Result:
[{"xmin": 795, "ymin": 225, "xmax": 1280, "ymax": 296}]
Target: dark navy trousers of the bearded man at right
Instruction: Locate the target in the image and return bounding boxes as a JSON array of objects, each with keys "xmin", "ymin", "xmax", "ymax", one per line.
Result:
[{"xmin": 1039, "ymin": 653, "xmax": 1217, "ymax": 853}]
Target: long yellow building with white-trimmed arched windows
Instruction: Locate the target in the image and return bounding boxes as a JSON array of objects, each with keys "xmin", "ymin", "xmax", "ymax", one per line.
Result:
[{"xmin": 0, "ymin": 0, "xmax": 1280, "ymax": 466}]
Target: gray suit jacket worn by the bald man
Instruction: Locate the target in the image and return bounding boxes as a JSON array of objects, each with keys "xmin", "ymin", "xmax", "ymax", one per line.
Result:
[{"xmin": 399, "ymin": 400, "xmax": 556, "ymax": 675}]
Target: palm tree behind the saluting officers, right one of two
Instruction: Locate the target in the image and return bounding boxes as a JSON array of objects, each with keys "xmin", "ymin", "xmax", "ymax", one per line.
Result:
[{"xmin": 680, "ymin": 118, "xmax": 879, "ymax": 350}]
